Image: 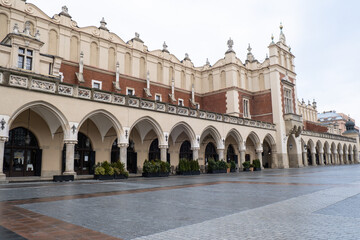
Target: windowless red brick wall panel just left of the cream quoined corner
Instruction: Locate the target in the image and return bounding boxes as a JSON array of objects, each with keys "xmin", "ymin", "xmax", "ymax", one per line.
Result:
[{"xmin": 201, "ymin": 92, "xmax": 226, "ymax": 113}]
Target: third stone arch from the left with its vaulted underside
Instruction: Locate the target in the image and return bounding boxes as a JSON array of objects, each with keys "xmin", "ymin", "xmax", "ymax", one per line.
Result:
[{"xmin": 129, "ymin": 116, "xmax": 166, "ymax": 144}]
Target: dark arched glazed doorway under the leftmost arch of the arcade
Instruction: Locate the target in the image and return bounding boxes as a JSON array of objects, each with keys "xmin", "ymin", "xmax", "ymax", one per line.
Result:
[{"xmin": 3, "ymin": 127, "xmax": 42, "ymax": 177}]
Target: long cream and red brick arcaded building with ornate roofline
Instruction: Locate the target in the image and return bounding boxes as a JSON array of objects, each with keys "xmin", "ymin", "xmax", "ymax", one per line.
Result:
[{"xmin": 0, "ymin": 0, "xmax": 359, "ymax": 180}]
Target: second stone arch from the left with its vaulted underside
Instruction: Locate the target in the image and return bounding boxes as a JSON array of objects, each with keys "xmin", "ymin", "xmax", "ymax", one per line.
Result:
[{"xmin": 78, "ymin": 109, "xmax": 122, "ymax": 143}]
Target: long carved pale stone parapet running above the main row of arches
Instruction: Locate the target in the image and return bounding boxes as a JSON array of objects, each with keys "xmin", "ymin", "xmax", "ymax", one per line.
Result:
[{"xmin": 0, "ymin": 73, "xmax": 278, "ymax": 131}]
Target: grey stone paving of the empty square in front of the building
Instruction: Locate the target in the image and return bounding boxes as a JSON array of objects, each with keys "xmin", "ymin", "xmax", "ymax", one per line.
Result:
[{"xmin": 0, "ymin": 165, "xmax": 360, "ymax": 240}]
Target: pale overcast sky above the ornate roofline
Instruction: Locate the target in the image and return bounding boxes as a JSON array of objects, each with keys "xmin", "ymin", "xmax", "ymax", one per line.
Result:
[{"xmin": 28, "ymin": 0, "xmax": 360, "ymax": 125}]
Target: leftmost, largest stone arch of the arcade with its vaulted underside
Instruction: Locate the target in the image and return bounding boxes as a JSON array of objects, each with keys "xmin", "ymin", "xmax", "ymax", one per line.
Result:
[{"xmin": 8, "ymin": 101, "xmax": 70, "ymax": 139}]
